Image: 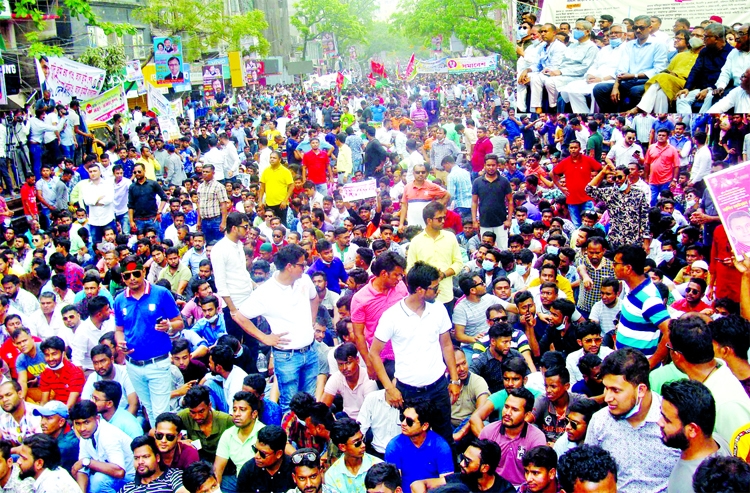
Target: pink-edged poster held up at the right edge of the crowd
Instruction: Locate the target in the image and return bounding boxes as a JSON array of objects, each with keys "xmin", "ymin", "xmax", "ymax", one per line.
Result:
[{"xmin": 703, "ymin": 161, "xmax": 750, "ymax": 260}]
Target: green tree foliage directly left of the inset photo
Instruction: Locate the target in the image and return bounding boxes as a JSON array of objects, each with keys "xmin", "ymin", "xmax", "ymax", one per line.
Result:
[{"xmin": 391, "ymin": 0, "xmax": 515, "ymax": 60}]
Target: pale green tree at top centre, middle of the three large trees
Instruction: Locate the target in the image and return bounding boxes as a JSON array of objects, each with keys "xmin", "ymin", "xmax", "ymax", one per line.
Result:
[{"xmin": 290, "ymin": 0, "xmax": 373, "ymax": 60}]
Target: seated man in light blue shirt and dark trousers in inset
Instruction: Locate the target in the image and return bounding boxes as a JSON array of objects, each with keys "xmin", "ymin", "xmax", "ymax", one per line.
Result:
[{"xmin": 593, "ymin": 15, "xmax": 667, "ymax": 113}]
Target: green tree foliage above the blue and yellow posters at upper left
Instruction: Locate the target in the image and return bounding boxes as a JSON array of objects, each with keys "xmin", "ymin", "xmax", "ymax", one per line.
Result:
[{"xmin": 135, "ymin": 0, "xmax": 270, "ymax": 62}]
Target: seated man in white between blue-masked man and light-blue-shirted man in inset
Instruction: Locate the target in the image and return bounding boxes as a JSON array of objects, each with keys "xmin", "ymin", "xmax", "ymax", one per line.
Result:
[{"xmin": 560, "ymin": 24, "xmax": 626, "ymax": 113}]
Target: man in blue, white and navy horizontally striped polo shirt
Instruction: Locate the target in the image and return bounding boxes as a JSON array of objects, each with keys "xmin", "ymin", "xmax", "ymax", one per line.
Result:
[{"xmin": 613, "ymin": 245, "xmax": 670, "ymax": 369}]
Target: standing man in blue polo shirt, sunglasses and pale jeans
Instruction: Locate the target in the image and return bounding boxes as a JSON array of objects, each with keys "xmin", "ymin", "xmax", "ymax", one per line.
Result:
[{"xmin": 115, "ymin": 255, "xmax": 183, "ymax": 426}]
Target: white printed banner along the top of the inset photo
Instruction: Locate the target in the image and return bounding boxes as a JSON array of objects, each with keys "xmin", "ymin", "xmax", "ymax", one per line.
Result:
[{"xmin": 540, "ymin": 0, "xmax": 750, "ymax": 33}]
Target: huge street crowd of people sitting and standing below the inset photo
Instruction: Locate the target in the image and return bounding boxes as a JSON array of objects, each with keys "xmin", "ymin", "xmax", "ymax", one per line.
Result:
[{"xmin": 0, "ymin": 72, "xmax": 750, "ymax": 493}]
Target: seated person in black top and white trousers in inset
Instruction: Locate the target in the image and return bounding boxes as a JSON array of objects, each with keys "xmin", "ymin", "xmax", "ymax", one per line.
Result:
[{"xmin": 675, "ymin": 24, "xmax": 732, "ymax": 114}]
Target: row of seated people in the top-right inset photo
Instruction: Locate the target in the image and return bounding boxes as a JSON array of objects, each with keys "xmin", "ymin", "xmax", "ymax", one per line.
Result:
[{"xmin": 516, "ymin": 13, "xmax": 750, "ymax": 114}]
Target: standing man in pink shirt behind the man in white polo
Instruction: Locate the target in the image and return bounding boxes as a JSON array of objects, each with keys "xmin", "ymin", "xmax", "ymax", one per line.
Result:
[{"xmin": 351, "ymin": 252, "xmax": 409, "ymax": 379}]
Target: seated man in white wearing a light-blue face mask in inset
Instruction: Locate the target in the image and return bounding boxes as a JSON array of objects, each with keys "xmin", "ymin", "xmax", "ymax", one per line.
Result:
[{"xmin": 529, "ymin": 21, "xmax": 599, "ymax": 112}]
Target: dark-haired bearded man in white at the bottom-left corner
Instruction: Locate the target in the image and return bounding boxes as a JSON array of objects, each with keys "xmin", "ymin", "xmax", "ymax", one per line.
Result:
[{"xmin": 18, "ymin": 433, "xmax": 81, "ymax": 493}]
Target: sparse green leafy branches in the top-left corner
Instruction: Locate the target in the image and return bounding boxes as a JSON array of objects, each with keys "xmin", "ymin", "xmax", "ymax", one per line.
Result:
[{"xmin": 12, "ymin": 0, "xmax": 136, "ymax": 58}]
